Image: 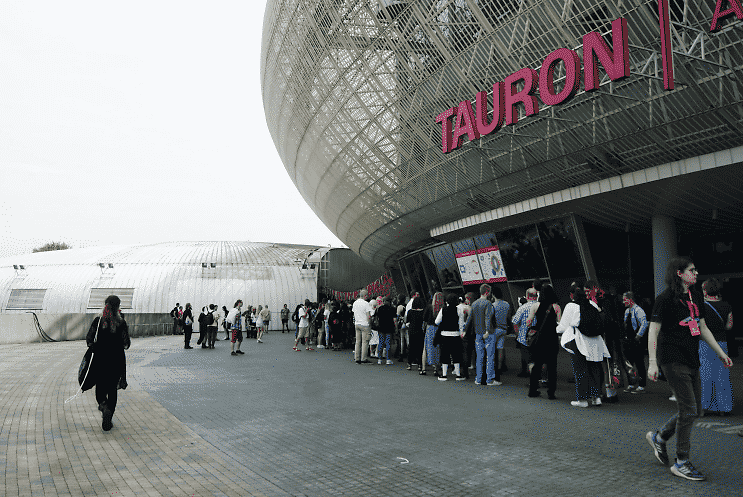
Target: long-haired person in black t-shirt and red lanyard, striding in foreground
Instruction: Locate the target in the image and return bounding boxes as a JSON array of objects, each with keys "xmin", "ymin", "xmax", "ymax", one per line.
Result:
[{"xmin": 645, "ymin": 257, "xmax": 733, "ymax": 481}]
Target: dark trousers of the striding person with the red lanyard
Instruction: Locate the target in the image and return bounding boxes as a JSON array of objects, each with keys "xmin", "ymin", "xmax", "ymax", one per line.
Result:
[{"xmin": 660, "ymin": 362, "xmax": 702, "ymax": 460}]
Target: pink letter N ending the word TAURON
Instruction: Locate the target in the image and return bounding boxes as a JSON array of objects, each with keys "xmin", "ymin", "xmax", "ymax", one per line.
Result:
[{"xmin": 583, "ymin": 17, "xmax": 630, "ymax": 91}]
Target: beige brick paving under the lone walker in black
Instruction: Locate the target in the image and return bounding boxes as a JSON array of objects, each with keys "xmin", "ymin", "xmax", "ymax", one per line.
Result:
[{"xmin": 0, "ymin": 339, "xmax": 287, "ymax": 496}]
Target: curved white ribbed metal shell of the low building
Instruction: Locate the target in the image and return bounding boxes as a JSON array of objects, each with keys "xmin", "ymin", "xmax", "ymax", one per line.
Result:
[{"xmin": 0, "ymin": 242, "xmax": 329, "ymax": 314}]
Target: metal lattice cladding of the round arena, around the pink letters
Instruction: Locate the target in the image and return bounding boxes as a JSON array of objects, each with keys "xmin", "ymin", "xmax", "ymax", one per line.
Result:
[{"xmin": 261, "ymin": 0, "xmax": 743, "ymax": 266}]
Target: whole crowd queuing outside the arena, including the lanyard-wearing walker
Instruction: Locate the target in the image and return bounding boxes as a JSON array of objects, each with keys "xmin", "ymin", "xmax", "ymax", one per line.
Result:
[{"xmin": 157, "ymin": 254, "xmax": 733, "ymax": 480}]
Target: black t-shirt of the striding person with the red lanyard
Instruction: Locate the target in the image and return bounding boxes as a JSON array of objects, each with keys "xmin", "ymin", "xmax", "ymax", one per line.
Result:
[{"xmin": 650, "ymin": 288, "xmax": 706, "ymax": 368}]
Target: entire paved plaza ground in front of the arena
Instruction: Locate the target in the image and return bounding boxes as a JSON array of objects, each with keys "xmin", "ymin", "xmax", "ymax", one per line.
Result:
[{"xmin": 0, "ymin": 331, "xmax": 743, "ymax": 497}]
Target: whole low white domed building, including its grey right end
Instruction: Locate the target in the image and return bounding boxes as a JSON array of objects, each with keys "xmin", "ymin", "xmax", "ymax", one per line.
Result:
[{"xmin": 0, "ymin": 242, "xmax": 382, "ymax": 343}]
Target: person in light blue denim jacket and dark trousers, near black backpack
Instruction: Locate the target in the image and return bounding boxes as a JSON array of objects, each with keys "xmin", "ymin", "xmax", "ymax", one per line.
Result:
[{"xmin": 622, "ymin": 292, "xmax": 648, "ymax": 393}]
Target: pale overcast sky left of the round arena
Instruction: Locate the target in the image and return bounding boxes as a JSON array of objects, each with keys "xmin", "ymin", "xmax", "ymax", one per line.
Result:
[{"xmin": 0, "ymin": 0, "xmax": 344, "ymax": 257}]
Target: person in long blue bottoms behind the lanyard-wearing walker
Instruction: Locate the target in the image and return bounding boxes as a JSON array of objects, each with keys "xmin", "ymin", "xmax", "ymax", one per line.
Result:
[{"xmin": 699, "ymin": 278, "xmax": 733, "ymax": 416}]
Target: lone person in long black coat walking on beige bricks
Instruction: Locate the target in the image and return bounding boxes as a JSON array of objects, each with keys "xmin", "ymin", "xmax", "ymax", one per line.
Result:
[{"xmin": 85, "ymin": 295, "xmax": 131, "ymax": 431}]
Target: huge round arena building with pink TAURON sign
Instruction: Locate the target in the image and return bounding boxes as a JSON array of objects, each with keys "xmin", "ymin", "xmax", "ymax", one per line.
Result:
[{"xmin": 261, "ymin": 0, "xmax": 743, "ymax": 308}]
